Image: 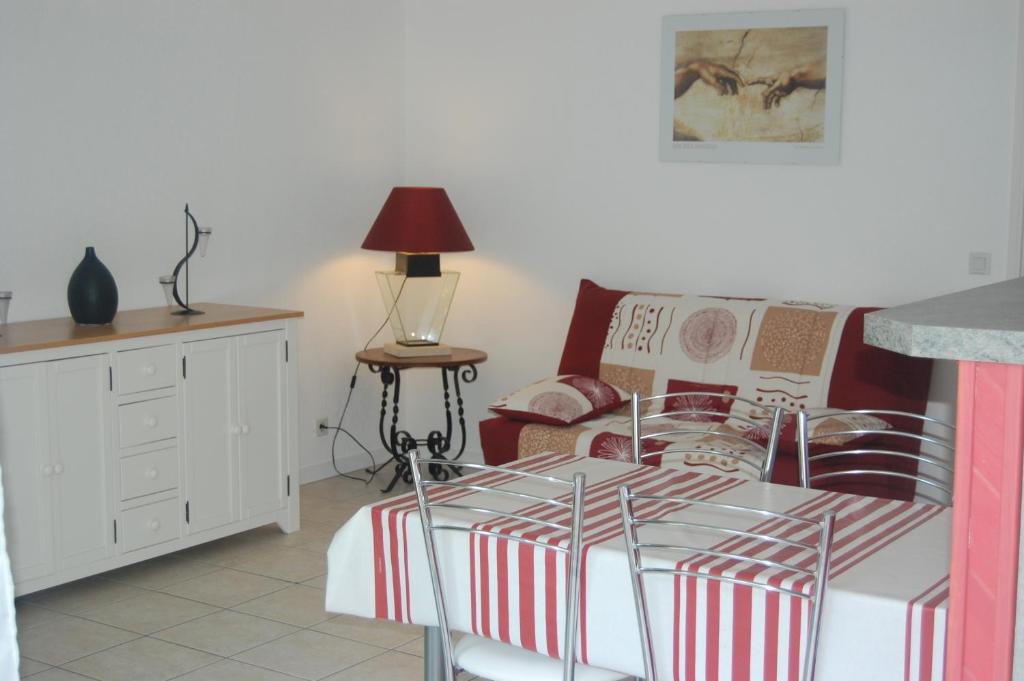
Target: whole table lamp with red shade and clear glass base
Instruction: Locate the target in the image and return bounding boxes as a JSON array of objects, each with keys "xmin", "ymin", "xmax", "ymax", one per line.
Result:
[{"xmin": 362, "ymin": 186, "xmax": 473, "ymax": 357}]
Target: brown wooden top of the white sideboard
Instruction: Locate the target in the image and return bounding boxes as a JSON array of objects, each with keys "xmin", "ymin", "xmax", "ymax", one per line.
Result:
[{"xmin": 0, "ymin": 303, "xmax": 302, "ymax": 354}]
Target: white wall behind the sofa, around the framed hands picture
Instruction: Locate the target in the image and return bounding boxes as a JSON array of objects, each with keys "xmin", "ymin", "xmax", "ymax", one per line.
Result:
[{"xmin": 406, "ymin": 0, "xmax": 1018, "ymax": 456}]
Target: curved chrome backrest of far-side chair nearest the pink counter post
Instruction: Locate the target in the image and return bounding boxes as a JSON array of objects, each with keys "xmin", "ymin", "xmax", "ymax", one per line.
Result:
[{"xmin": 797, "ymin": 409, "xmax": 956, "ymax": 506}]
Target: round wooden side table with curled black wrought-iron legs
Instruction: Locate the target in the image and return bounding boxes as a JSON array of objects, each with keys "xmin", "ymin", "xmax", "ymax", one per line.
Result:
[{"xmin": 355, "ymin": 347, "xmax": 487, "ymax": 492}]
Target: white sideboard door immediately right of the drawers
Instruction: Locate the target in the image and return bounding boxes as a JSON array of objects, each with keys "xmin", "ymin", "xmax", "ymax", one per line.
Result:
[{"xmin": 182, "ymin": 338, "xmax": 239, "ymax": 533}]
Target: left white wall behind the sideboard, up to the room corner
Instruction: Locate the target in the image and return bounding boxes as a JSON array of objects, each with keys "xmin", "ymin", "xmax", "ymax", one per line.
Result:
[{"xmin": 0, "ymin": 0, "xmax": 404, "ymax": 472}]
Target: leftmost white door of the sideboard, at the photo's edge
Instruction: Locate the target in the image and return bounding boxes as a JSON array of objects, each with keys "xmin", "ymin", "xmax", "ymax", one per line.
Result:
[{"xmin": 0, "ymin": 364, "xmax": 53, "ymax": 582}]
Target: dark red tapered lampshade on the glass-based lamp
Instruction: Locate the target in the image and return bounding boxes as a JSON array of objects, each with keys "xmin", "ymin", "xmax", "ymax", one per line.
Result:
[{"xmin": 362, "ymin": 186, "xmax": 473, "ymax": 253}]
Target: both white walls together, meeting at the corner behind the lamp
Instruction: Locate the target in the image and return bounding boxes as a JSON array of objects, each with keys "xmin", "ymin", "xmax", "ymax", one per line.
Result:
[{"xmin": 0, "ymin": 0, "xmax": 1018, "ymax": 478}]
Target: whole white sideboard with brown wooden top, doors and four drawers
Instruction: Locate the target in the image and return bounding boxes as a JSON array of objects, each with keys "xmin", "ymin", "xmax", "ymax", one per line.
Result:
[{"xmin": 0, "ymin": 304, "xmax": 302, "ymax": 595}]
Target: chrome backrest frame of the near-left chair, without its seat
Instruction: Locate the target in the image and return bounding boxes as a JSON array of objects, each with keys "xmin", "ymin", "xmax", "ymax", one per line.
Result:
[{"xmin": 409, "ymin": 451, "xmax": 586, "ymax": 681}]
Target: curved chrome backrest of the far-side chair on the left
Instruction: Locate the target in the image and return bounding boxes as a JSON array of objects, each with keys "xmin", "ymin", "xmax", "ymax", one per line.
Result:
[{"xmin": 630, "ymin": 391, "xmax": 784, "ymax": 482}]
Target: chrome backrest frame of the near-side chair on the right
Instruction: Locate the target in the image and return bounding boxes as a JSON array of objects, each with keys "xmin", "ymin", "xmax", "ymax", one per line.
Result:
[{"xmin": 618, "ymin": 485, "xmax": 836, "ymax": 681}]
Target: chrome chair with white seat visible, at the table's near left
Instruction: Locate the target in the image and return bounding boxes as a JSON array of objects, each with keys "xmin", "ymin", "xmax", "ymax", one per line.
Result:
[{"xmin": 409, "ymin": 452, "xmax": 627, "ymax": 681}]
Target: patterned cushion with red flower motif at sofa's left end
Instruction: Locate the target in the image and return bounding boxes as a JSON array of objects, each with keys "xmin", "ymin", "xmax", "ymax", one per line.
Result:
[{"xmin": 489, "ymin": 374, "xmax": 630, "ymax": 426}]
